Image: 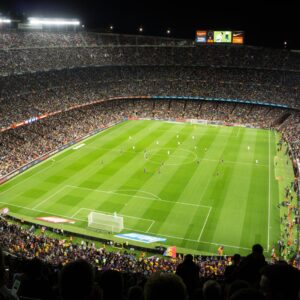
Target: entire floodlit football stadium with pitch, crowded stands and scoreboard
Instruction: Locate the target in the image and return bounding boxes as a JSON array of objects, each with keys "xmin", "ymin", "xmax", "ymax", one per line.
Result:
[{"xmin": 0, "ymin": 13, "xmax": 300, "ymax": 299}]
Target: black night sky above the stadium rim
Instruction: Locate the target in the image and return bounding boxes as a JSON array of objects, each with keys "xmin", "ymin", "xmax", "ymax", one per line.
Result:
[{"xmin": 0, "ymin": 0, "xmax": 300, "ymax": 49}]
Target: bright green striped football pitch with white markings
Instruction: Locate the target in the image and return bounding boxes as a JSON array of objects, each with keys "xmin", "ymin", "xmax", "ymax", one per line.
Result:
[{"xmin": 0, "ymin": 121, "xmax": 292, "ymax": 254}]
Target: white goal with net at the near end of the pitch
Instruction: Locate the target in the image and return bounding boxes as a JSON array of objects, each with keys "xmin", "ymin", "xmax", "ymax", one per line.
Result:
[{"xmin": 88, "ymin": 211, "xmax": 124, "ymax": 232}]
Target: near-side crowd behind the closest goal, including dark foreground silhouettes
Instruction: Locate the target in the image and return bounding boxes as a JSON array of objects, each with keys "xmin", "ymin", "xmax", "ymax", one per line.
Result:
[{"xmin": 0, "ymin": 218, "xmax": 300, "ymax": 300}]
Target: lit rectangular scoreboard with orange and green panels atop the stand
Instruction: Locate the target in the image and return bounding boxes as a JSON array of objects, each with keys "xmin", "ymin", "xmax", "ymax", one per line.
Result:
[{"xmin": 196, "ymin": 30, "xmax": 244, "ymax": 45}]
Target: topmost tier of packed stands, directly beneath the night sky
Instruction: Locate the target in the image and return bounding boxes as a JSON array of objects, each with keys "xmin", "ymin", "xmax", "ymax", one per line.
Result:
[{"xmin": 0, "ymin": 31, "xmax": 300, "ymax": 75}]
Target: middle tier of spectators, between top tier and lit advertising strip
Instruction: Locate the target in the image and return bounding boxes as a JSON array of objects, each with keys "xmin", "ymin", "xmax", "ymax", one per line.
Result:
[{"xmin": 0, "ymin": 66, "xmax": 300, "ymax": 127}]
